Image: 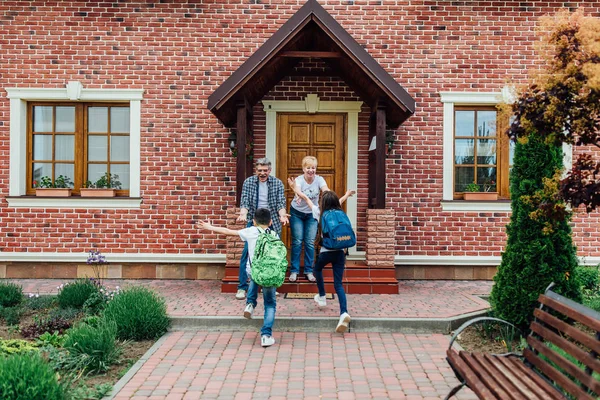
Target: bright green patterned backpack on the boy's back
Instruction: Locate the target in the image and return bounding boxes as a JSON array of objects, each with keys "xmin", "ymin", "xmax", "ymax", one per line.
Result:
[{"xmin": 250, "ymin": 229, "xmax": 288, "ymax": 287}]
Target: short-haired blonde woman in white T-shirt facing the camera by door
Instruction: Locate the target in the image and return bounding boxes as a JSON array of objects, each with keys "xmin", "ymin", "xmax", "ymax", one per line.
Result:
[{"xmin": 290, "ymin": 156, "xmax": 329, "ymax": 282}]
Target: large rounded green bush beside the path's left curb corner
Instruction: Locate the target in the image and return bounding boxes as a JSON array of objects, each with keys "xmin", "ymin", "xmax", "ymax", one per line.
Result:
[{"xmin": 104, "ymin": 287, "xmax": 170, "ymax": 340}]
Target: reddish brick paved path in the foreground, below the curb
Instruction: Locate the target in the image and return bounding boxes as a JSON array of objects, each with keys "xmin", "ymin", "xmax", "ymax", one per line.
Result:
[{"xmin": 115, "ymin": 332, "xmax": 476, "ymax": 400}]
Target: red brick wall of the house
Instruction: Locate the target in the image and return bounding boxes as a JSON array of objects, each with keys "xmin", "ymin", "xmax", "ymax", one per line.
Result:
[{"xmin": 0, "ymin": 0, "xmax": 600, "ymax": 257}]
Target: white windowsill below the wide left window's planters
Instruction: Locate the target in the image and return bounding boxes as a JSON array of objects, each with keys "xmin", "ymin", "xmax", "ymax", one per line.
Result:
[{"xmin": 6, "ymin": 196, "xmax": 142, "ymax": 210}]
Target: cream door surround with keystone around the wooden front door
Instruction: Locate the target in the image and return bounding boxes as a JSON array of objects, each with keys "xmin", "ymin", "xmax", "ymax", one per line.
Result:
[{"xmin": 262, "ymin": 94, "xmax": 363, "ymax": 253}]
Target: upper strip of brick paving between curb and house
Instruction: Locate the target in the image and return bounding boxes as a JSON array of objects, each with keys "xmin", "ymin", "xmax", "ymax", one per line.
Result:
[{"xmin": 10, "ymin": 279, "xmax": 492, "ymax": 318}]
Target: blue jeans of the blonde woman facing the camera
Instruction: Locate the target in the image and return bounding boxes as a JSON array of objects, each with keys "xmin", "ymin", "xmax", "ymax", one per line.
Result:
[{"xmin": 290, "ymin": 207, "xmax": 319, "ymax": 274}]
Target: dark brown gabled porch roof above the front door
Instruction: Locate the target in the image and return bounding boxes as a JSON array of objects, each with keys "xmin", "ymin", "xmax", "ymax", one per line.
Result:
[{"xmin": 208, "ymin": 0, "xmax": 415, "ymax": 129}]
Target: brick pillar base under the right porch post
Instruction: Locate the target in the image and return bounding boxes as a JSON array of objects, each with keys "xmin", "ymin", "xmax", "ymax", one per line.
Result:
[{"xmin": 366, "ymin": 208, "xmax": 396, "ymax": 268}]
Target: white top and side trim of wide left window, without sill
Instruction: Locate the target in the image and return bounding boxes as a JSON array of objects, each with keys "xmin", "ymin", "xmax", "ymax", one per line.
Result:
[{"xmin": 5, "ymin": 81, "xmax": 144, "ymax": 208}]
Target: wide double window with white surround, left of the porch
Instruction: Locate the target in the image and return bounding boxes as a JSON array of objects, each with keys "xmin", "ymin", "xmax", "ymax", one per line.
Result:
[{"xmin": 5, "ymin": 81, "xmax": 143, "ymax": 208}]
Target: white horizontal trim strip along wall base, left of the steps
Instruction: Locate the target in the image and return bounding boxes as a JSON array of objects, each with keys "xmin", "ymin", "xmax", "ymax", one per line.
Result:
[{"xmin": 0, "ymin": 252, "xmax": 225, "ymax": 264}]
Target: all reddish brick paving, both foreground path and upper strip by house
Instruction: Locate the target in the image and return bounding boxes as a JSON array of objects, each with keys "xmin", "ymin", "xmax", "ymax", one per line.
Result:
[{"xmin": 10, "ymin": 279, "xmax": 492, "ymax": 400}]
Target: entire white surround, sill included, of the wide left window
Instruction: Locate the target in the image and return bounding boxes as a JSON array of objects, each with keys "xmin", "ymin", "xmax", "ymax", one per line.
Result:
[{"xmin": 5, "ymin": 81, "xmax": 144, "ymax": 209}]
